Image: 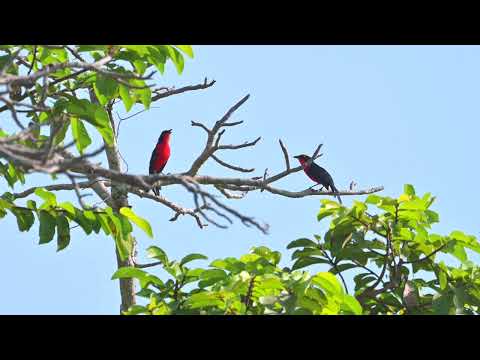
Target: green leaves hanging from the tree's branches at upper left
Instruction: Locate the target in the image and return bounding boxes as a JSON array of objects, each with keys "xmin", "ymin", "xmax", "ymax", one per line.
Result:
[{"xmin": 0, "ymin": 45, "xmax": 193, "ymax": 259}]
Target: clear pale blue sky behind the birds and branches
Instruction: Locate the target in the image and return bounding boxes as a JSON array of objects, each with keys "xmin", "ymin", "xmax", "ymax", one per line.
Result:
[{"xmin": 0, "ymin": 46, "xmax": 480, "ymax": 314}]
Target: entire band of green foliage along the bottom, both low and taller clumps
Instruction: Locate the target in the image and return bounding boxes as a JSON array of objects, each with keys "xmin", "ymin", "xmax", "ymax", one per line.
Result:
[{"xmin": 114, "ymin": 185, "xmax": 480, "ymax": 315}]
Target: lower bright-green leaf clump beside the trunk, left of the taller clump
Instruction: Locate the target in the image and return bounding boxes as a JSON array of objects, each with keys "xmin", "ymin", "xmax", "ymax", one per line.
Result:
[{"xmin": 116, "ymin": 246, "xmax": 362, "ymax": 315}]
